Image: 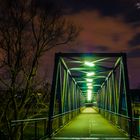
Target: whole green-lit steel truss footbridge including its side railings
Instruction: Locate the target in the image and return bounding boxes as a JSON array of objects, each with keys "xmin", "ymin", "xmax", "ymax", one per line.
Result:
[{"xmin": 11, "ymin": 53, "xmax": 140, "ymax": 140}]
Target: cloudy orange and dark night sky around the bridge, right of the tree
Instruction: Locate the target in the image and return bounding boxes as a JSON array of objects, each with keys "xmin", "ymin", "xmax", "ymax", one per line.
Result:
[{"xmin": 41, "ymin": 0, "xmax": 140, "ymax": 88}]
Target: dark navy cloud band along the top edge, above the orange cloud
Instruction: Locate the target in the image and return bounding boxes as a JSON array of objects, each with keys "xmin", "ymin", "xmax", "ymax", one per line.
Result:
[{"xmin": 62, "ymin": 0, "xmax": 140, "ymax": 23}]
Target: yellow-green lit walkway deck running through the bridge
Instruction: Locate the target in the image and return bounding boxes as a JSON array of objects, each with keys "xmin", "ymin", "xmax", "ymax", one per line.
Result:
[{"xmin": 52, "ymin": 108, "xmax": 128, "ymax": 140}]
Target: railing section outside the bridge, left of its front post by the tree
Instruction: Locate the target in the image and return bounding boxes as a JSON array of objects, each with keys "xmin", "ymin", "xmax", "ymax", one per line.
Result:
[{"xmin": 10, "ymin": 118, "xmax": 48, "ymax": 140}]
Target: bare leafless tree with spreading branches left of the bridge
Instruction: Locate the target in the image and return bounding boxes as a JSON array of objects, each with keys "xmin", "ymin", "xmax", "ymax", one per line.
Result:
[{"xmin": 0, "ymin": 0, "xmax": 79, "ymax": 139}]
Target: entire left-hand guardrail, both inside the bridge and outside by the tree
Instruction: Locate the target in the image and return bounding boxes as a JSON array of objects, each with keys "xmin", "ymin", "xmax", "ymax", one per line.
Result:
[{"xmin": 10, "ymin": 108, "xmax": 80, "ymax": 140}]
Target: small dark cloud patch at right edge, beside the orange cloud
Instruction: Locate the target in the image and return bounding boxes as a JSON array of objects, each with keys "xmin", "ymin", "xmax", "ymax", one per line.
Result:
[{"xmin": 128, "ymin": 33, "xmax": 140, "ymax": 47}]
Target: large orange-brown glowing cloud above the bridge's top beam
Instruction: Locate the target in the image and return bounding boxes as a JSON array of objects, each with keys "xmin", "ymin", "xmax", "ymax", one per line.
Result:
[{"xmin": 67, "ymin": 11, "xmax": 135, "ymax": 52}]
